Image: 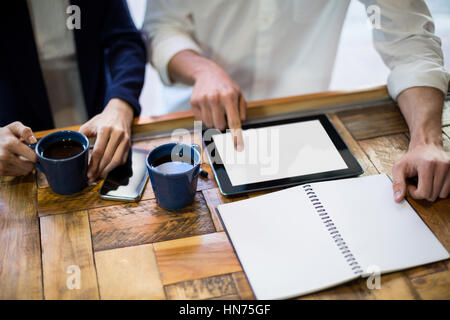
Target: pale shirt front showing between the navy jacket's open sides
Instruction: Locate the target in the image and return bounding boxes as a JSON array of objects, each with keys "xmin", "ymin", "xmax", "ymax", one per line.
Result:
[{"xmin": 28, "ymin": 0, "xmax": 88, "ymax": 128}]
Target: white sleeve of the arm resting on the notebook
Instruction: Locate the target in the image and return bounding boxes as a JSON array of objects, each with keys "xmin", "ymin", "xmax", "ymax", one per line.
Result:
[{"xmin": 360, "ymin": 0, "xmax": 450, "ymax": 100}]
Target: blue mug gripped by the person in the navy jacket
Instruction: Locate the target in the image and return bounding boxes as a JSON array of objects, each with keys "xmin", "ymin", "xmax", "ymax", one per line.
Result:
[{"xmin": 34, "ymin": 130, "xmax": 89, "ymax": 194}]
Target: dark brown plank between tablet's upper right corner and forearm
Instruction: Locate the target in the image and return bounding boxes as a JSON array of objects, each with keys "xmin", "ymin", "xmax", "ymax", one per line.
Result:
[{"xmin": 337, "ymin": 103, "xmax": 408, "ymax": 140}]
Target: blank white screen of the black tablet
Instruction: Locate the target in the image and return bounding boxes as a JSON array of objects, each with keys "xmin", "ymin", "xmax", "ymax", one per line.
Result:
[{"xmin": 212, "ymin": 120, "xmax": 348, "ymax": 186}]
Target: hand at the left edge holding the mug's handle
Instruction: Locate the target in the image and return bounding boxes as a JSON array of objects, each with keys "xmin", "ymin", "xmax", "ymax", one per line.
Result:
[{"xmin": 0, "ymin": 121, "xmax": 38, "ymax": 176}]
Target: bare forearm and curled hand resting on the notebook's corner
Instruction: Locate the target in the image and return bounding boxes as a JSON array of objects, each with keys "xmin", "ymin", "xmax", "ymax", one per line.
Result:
[{"xmin": 392, "ymin": 87, "xmax": 450, "ymax": 201}]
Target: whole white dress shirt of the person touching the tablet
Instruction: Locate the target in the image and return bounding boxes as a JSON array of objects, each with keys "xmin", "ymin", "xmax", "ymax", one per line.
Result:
[{"xmin": 143, "ymin": 0, "xmax": 449, "ymax": 112}]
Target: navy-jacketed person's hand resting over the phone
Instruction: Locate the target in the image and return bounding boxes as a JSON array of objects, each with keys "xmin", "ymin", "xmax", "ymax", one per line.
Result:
[{"xmin": 80, "ymin": 98, "xmax": 134, "ymax": 183}]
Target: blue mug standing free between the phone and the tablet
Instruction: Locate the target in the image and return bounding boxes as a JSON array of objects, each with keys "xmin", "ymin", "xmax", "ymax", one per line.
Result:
[{"xmin": 147, "ymin": 143, "xmax": 201, "ymax": 210}]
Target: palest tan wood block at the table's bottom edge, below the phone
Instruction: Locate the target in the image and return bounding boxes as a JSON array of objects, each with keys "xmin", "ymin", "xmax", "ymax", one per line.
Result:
[{"xmin": 95, "ymin": 244, "xmax": 165, "ymax": 300}]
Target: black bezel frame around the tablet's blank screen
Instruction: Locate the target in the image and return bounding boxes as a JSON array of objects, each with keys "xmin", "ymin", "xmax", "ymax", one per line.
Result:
[{"xmin": 202, "ymin": 114, "xmax": 364, "ymax": 196}]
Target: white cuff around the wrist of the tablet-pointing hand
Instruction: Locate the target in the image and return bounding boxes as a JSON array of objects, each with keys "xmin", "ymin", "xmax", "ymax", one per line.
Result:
[{"xmin": 153, "ymin": 35, "xmax": 202, "ymax": 86}]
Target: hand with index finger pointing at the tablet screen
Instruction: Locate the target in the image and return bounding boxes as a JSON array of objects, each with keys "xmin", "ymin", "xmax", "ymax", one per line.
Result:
[{"xmin": 169, "ymin": 50, "xmax": 247, "ymax": 151}]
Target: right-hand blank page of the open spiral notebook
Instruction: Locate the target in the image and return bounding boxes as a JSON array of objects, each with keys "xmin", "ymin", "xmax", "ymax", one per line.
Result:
[{"xmin": 310, "ymin": 174, "xmax": 449, "ymax": 273}]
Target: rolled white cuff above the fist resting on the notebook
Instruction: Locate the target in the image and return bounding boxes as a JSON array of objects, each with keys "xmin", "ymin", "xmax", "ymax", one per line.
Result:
[{"xmin": 387, "ymin": 61, "xmax": 450, "ymax": 100}]
